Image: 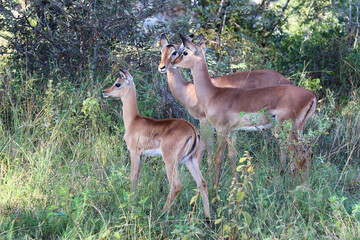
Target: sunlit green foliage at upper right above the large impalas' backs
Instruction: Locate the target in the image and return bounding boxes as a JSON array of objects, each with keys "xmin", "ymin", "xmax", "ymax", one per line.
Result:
[{"xmin": 195, "ymin": 0, "xmax": 360, "ymax": 96}]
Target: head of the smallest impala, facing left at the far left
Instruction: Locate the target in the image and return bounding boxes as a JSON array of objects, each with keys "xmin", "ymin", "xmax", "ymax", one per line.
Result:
[{"xmin": 103, "ymin": 68, "xmax": 134, "ymax": 98}]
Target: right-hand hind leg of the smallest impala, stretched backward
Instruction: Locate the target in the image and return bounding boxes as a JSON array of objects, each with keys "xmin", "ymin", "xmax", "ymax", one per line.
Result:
[{"xmin": 185, "ymin": 158, "xmax": 210, "ymax": 220}]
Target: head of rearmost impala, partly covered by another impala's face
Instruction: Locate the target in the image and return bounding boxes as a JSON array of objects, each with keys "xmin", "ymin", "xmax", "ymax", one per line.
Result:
[{"xmin": 158, "ymin": 34, "xmax": 179, "ymax": 73}]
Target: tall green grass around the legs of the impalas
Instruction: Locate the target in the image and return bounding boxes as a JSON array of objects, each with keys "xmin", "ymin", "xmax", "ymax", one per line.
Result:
[{"xmin": 0, "ymin": 69, "xmax": 360, "ymax": 239}]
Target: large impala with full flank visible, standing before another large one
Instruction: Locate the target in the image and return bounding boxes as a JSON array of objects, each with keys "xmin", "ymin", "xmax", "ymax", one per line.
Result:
[{"xmin": 172, "ymin": 35, "xmax": 317, "ymax": 184}]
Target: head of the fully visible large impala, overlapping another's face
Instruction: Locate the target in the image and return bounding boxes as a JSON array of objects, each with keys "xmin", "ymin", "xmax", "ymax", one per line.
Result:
[{"xmin": 171, "ymin": 34, "xmax": 206, "ymax": 68}]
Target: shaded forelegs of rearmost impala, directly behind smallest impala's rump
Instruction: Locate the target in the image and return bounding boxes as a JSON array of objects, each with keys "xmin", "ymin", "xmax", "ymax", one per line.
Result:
[{"xmin": 199, "ymin": 119, "xmax": 215, "ymax": 168}]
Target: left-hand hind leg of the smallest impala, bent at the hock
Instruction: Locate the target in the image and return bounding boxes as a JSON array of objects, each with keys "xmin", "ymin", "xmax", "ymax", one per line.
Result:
[{"xmin": 163, "ymin": 152, "xmax": 181, "ymax": 211}]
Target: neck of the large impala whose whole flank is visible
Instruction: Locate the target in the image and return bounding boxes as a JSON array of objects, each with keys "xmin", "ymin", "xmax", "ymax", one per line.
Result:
[{"xmin": 191, "ymin": 59, "xmax": 216, "ymax": 106}]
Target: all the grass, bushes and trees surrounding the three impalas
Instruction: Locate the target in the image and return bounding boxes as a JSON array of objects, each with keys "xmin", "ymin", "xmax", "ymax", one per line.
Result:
[{"xmin": 0, "ymin": 0, "xmax": 360, "ymax": 239}]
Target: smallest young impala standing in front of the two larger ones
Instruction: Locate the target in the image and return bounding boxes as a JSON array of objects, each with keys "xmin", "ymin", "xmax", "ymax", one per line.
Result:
[{"xmin": 103, "ymin": 70, "xmax": 210, "ymax": 219}]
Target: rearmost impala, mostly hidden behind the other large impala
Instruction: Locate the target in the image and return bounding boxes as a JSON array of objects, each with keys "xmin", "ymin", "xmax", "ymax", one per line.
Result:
[{"xmin": 158, "ymin": 34, "xmax": 290, "ymax": 170}]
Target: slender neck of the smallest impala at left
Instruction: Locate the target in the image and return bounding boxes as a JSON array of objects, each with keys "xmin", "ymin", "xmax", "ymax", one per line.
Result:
[{"xmin": 121, "ymin": 83, "xmax": 140, "ymax": 129}]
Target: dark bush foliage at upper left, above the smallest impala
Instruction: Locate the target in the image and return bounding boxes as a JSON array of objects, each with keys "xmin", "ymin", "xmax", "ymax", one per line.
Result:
[{"xmin": 0, "ymin": 0, "xmax": 193, "ymax": 81}]
